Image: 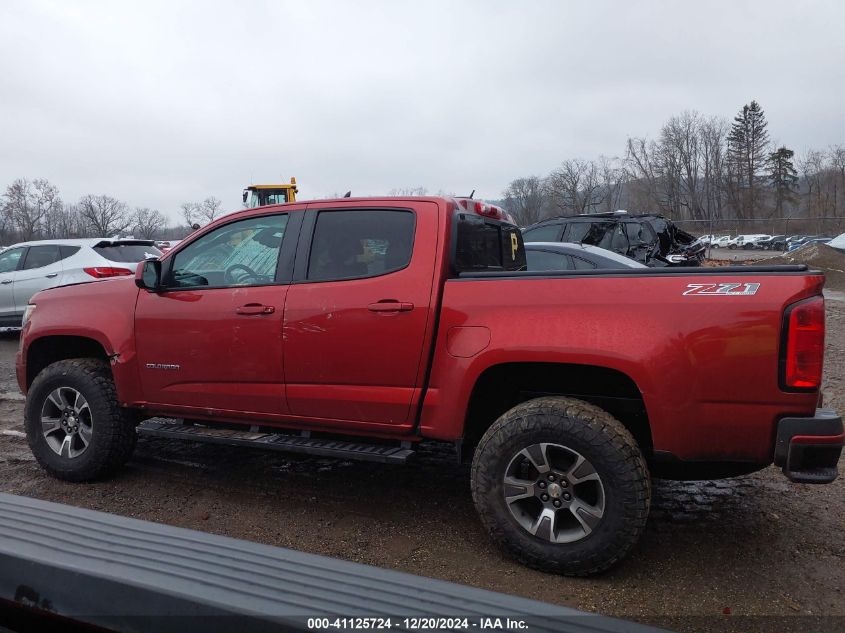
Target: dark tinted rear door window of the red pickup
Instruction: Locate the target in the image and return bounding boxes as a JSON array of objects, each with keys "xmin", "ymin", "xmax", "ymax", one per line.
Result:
[{"xmin": 308, "ymin": 209, "xmax": 416, "ymax": 281}]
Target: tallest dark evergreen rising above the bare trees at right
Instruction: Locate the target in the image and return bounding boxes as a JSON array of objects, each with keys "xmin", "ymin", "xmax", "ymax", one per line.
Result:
[{"xmin": 728, "ymin": 101, "xmax": 769, "ymax": 217}]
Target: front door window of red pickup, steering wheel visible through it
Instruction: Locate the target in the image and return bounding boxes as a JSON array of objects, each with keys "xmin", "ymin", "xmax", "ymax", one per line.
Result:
[{"xmin": 165, "ymin": 214, "xmax": 288, "ymax": 288}]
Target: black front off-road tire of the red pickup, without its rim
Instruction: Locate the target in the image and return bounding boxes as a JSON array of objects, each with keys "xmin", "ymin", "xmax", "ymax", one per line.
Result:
[{"xmin": 25, "ymin": 358, "xmax": 137, "ymax": 481}]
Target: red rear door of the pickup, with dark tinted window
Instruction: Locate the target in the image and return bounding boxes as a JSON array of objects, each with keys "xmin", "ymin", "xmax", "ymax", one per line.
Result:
[{"xmin": 284, "ymin": 201, "xmax": 439, "ymax": 428}]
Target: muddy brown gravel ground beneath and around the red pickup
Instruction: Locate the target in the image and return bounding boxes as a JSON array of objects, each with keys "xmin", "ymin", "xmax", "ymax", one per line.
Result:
[{"xmin": 0, "ymin": 292, "xmax": 845, "ymax": 633}]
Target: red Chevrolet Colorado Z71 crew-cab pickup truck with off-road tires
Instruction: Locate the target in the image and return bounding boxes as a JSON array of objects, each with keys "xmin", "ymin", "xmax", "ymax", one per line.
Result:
[{"xmin": 17, "ymin": 198, "xmax": 843, "ymax": 575}]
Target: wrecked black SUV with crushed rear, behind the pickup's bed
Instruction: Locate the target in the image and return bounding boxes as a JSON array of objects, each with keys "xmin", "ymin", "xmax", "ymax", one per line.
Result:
[{"xmin": 522, "ymin": 211, "xmax": 705, "ymax": 267}]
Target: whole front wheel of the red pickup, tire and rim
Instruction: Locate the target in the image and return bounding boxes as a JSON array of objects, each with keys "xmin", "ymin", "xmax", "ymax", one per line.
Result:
[{"xmin": 25, "ymin": 358, "xmax": 137, "ymax": 481}]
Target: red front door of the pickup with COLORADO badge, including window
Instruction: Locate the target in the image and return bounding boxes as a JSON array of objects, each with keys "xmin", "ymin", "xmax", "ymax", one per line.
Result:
[{"xmin": 135, "ymin": 213, "xmax": 301, "ymax": 416}]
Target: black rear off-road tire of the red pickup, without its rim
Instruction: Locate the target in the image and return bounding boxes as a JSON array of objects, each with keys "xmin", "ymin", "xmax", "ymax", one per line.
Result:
[{"xmin": 471, "ymin": 397, "xmax": 651, "ymax": 576}]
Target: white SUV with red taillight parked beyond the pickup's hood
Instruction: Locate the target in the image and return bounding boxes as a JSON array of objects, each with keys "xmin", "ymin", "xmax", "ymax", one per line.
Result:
[{"xmin": 0, "ymin": 238, "xmax": 161, "ymax": 330}]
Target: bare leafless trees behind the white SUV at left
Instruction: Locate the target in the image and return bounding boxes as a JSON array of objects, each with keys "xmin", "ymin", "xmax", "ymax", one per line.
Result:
[{"xmin": 0, "ymin": 178, "xmax": 222, "ymax": 245}]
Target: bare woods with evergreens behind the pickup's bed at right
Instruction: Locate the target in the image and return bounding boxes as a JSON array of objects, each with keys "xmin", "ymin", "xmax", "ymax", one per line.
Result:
[{"xmin": 501, "ymin": 101, "xmax": 845, "ymax": 232}]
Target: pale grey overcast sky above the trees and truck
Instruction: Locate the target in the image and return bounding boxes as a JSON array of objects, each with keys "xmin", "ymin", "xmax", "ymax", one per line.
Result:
[{"xmin": 0, "ymin": 0, "xmax": 845, "ymax": 219}]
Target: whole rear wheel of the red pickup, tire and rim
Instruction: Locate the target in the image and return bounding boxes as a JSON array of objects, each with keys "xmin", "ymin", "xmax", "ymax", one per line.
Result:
[{"xmin": 472, "ymin": 397, "xmax": 651, "ymax": 576}]
